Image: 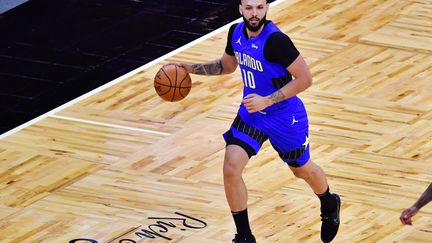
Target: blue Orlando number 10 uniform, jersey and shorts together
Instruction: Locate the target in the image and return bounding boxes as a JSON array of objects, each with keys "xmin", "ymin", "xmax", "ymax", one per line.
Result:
[{"xmin": 224, "ymin": 21, "xmax": 310, "ymax": 167}]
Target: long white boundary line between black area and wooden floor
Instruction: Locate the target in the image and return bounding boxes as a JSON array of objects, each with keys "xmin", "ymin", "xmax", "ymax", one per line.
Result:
[{"xmin": 0, "ymin": 0, "xmax": 286, "ymax": 140}]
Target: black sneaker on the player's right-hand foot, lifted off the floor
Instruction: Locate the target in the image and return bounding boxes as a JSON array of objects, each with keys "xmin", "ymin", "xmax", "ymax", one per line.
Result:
[{"xmin": 321, "ymin": 194, "xmax": 341, "ymax": 243}]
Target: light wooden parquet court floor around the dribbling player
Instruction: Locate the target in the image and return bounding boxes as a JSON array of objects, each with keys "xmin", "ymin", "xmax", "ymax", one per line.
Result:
[{"xmin": 0, "ymin": 0, "xmax": 432, "ymax": 243}]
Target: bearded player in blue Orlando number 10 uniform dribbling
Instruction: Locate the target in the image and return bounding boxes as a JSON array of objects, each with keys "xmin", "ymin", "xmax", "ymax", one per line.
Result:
[{"xmin": 169, "ymin": 0, "xmax": 341, "ymax": 242}]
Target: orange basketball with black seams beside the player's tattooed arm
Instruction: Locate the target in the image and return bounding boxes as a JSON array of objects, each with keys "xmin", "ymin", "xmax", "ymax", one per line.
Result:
[{"xmin": 154, "ymin": 64, "xmax": 192, "ymax": 102}]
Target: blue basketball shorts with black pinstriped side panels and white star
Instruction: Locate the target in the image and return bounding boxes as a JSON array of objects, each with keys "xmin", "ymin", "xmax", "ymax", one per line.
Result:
[{"xmin": 223, "ymin": 99, "xmax": 310, "ymax": 167}]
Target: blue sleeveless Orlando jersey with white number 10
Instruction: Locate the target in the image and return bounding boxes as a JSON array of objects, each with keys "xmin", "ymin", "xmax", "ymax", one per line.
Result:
[{"xmin": 231, "ymin": 21, "xmax": 300, "ymax": 112}]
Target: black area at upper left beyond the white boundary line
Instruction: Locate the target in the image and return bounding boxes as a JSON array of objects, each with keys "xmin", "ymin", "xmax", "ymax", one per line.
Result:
[{"xmin": 0, "ymin": 0, "xmax": 272, "ymax": 134}]
